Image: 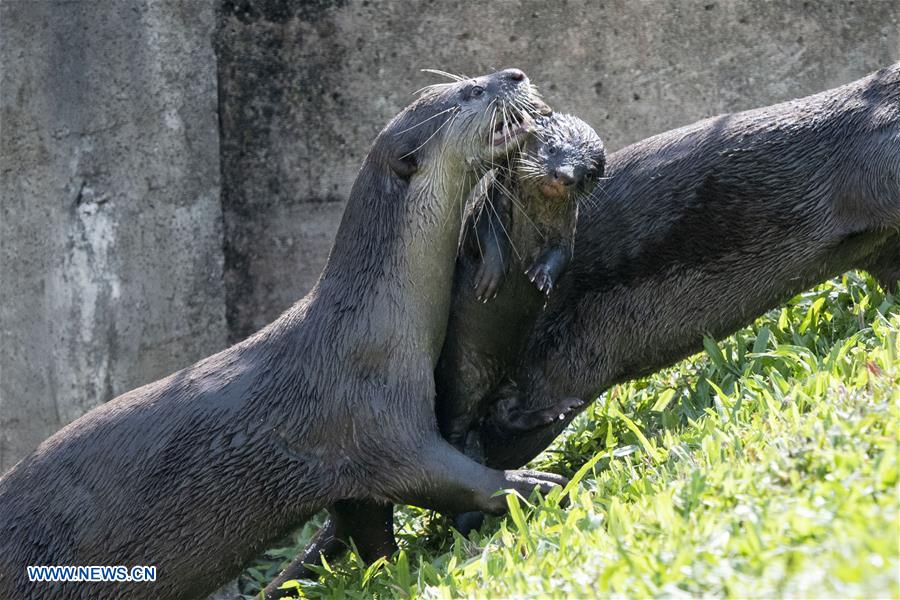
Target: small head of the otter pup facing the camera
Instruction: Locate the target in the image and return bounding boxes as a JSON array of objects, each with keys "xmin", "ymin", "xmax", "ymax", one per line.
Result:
[{"xmin": 515, "ymin": 114, "xmax": 606, "ymax": 200}]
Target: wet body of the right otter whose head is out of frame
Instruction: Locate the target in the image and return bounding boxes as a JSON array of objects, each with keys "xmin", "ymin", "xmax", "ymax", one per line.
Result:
[{"xmin": 481, "ymin": 63, "xmax": 900, "ymax": 466}]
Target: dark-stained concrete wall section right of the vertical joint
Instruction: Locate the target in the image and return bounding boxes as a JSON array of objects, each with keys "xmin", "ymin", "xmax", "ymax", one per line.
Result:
[{"xmin": 217, "ymin": 0, "xmax": 900, "ymax": 339}]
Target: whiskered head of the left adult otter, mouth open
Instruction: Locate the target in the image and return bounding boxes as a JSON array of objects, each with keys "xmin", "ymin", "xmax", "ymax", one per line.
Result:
[{"xmin": 373, "ymin": 69, "xmax": 549, "ymax": 180}]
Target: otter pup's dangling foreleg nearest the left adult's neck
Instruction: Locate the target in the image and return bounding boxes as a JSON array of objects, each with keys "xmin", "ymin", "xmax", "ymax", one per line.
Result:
[{"xmin": 470, "ymin": 180, "xmax": 512, "ymax": 302}]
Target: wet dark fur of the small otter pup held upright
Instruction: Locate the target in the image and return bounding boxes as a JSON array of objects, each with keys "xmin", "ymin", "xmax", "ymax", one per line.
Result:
[{"xmin": 435, "ymin": 115, "xmax": 606, "ymax": 449}]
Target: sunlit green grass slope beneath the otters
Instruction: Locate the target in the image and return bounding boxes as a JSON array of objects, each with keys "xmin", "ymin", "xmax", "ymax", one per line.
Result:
[{"xmin": 242, "ymin": 273, "xmax": 900, "ymax": 598}]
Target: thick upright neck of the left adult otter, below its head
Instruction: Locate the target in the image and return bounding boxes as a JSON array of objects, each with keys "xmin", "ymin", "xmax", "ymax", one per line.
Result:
[{"xmin": 314, "ymin": 162, "xmax": 476, "ymax": 367}]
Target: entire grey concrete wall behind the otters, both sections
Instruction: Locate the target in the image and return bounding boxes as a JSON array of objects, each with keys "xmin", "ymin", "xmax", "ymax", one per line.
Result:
[{"xmin": 0, "ymin": 0, "xmax": 900, "ymax": 471}]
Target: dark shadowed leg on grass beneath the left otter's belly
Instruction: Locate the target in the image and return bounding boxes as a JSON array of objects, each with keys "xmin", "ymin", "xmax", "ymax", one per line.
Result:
[{"xmin": 265, "ymin": 500, "xmax": 397, "ymax": 598}]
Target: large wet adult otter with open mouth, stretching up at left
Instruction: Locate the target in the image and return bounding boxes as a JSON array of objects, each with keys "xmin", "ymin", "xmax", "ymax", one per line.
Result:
[{"xmin": 0, "ymin": 69, "xmax": 562, "ymax": 598}]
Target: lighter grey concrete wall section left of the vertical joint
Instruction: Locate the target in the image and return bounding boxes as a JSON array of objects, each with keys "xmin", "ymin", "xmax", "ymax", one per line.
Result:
[{"xmin": 0, "ymin": 0, "xmax": 227, "ymax": 472}]
